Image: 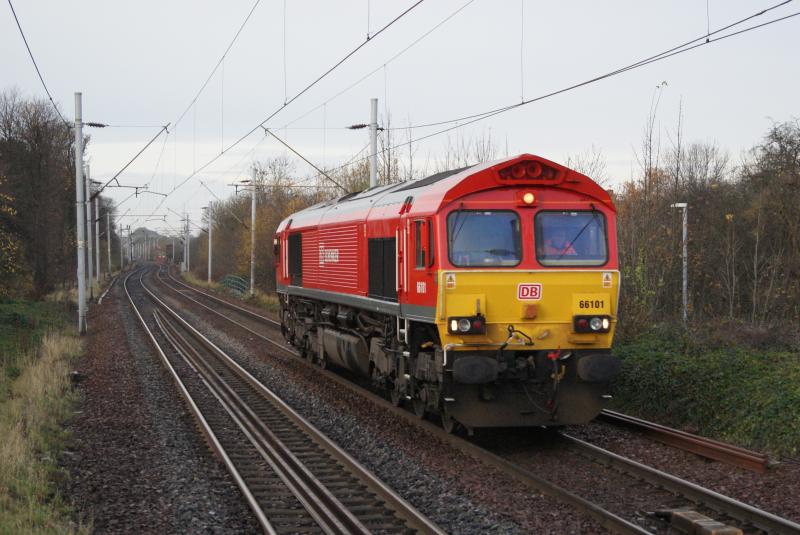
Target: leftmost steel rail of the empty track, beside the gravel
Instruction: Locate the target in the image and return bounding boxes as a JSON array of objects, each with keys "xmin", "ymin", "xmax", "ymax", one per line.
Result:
[{"xmin": 123, "ymin": 268, "xmax": 277, "ymax": 535}]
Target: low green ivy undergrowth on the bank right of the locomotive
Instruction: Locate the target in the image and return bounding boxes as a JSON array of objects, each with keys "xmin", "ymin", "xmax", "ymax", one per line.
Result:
[{"xmin": 614, "ymin": 328, "xmax": 800, "ymax": 455}]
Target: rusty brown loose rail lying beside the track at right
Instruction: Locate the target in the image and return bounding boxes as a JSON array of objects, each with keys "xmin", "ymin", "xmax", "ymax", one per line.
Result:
[{"xmin": 598, "ymin": 410, "xmax": 772, "ymax": 472}]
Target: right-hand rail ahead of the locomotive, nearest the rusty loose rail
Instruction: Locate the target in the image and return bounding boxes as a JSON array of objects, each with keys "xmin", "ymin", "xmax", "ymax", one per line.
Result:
[{"xmin": 561, "ymin": 433, "xmax": 800, "ymax": 535}]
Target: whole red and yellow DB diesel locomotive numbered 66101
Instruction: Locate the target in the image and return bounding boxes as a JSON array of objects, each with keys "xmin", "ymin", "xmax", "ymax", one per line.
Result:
[{"xmin": 274, "ymin": 154, "xmax": 620, "ymax": 431}]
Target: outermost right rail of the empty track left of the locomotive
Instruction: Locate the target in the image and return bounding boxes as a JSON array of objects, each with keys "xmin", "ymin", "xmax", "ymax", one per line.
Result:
[{"xmin": 136, "ymin": 268, "xmax": 444, "ymax": 534}]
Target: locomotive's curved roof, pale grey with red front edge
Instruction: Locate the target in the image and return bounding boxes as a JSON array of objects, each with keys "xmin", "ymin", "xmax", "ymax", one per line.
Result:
[{"xmin": 278, "ymin": 154, "xmax": 614, "ymax": 231}]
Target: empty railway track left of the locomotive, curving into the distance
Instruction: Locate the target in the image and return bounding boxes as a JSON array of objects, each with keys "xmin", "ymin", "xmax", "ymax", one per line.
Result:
[{"xmin": 125, "ymin": 268, "xmax": 442, "ymax": 533}]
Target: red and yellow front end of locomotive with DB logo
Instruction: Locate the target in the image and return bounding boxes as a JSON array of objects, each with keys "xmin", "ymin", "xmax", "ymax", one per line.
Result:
[{"xmin": 421, "ymin": 160, "xmax": 620, "ymax": 428}]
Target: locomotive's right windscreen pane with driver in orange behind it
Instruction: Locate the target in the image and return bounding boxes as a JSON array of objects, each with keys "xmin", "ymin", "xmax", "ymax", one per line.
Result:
[{"xmin": 534, "ymin": 210, "xmax": 608, "ymax": 266}]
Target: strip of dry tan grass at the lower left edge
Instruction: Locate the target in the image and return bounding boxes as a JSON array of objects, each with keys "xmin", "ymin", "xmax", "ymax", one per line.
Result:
[{"xmin": 0, "ymin": 332, "xmax": 89, "ymax": 534}]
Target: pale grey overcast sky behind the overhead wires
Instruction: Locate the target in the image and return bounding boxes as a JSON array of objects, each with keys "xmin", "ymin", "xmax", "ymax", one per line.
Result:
[{"xmin": 0, "ymin": 0, "xmax": 800, "ymax": 234}]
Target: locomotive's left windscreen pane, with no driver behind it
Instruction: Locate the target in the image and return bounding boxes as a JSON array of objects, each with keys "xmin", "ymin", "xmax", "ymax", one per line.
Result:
[{"xmin": 447, "ymin": 210, "xmax": 522, "ymax": 267}]
